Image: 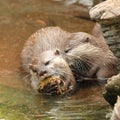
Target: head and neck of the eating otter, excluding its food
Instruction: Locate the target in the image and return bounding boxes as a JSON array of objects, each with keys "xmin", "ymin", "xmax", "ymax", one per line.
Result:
[{"xmin": 28, "ymin": 50, "xmax": 76, "ymax": 95}]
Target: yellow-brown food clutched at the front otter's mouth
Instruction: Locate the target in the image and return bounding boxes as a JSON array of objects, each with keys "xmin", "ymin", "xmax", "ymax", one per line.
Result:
[{"xmin": 38, "ymin": 76, "xmax": 75, "ymax": 95}]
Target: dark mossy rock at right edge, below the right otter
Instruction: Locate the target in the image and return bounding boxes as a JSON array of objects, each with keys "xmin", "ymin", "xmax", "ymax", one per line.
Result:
[{"xmin": 103, "ymin": 74, "xmax": 120, "ymax": 106}]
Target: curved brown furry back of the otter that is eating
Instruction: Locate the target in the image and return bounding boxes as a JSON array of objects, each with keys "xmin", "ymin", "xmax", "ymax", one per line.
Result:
[{"xmin": 21, "ymin": 27, "xmax": 70, "ymax": 72}]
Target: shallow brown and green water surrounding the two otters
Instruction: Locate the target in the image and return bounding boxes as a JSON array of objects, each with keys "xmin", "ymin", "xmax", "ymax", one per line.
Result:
[{"xmin": 0, "ymin": 0, "xmax": 109, "ymax": 120}]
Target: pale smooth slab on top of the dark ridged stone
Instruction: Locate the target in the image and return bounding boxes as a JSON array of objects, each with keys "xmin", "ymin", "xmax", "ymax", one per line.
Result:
[{"xmin": 89, "ymin": 0, "xmax": 120, "ymax": 21}]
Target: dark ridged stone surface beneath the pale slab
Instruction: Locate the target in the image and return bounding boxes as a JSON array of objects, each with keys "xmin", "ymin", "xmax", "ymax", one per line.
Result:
[{"xmin": 99, "ymin": 17, "xmax": 120, "ymax": 71}]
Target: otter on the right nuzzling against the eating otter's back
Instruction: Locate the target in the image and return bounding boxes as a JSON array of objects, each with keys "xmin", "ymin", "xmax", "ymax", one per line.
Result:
[{"xmin": 66, "ymin": 32, "xmax": 117, "ymax": 80}]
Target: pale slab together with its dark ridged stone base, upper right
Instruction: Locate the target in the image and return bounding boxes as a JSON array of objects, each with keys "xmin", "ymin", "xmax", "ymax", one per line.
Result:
[{"xmin": 89, "ymin": 0, "xmax": 120, "ymax": 71}]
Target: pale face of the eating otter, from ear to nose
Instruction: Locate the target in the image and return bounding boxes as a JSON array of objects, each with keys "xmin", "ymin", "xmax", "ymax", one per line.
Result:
[{"xmin": 38, "ymin": 50, "xmax": 62, "ymax": 80}]
